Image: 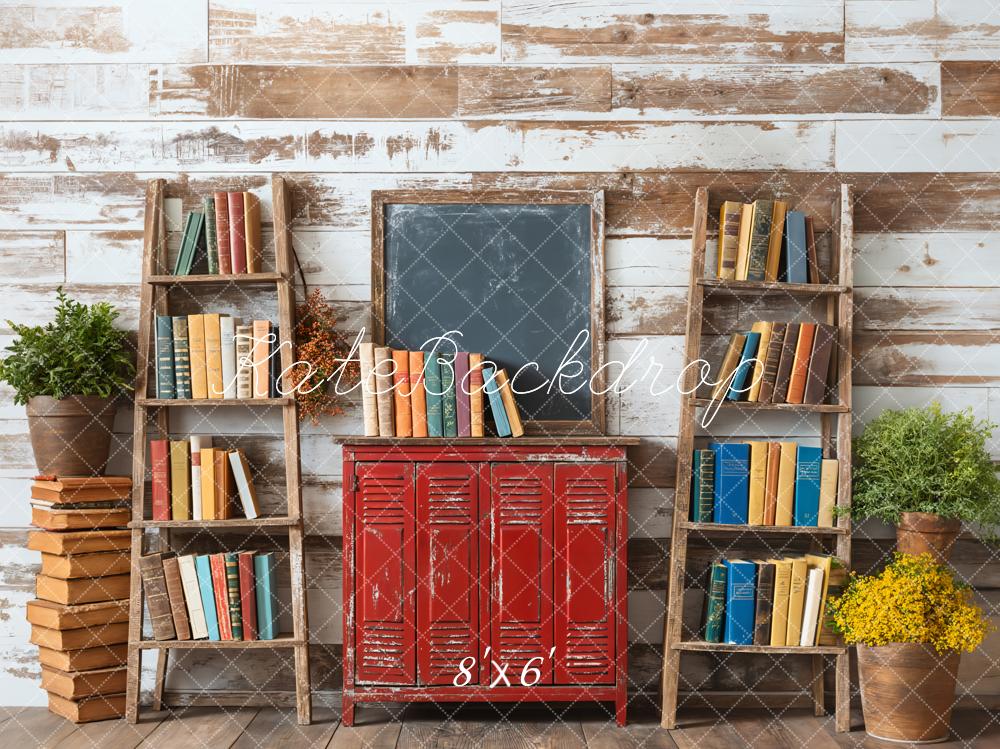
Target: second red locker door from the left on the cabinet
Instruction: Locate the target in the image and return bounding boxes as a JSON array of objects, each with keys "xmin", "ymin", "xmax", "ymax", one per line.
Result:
[{"xmin": 417, "ymin": 463, "xmax": 485, "ymax": 684}]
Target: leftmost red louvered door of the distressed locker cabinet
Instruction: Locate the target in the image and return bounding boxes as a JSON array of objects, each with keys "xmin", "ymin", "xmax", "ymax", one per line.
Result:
[{"xmin": 354, "ymin": 463, "xmax": 417, "ymax": 684}]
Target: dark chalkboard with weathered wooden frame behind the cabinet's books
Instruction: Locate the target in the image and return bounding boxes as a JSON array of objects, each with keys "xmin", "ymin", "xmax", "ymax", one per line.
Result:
[{"xmin": 372, "ymin": 190, "xmax": 605, "ymax": 436}]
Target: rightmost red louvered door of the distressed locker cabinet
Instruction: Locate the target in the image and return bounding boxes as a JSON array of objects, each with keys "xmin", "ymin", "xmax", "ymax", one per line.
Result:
[{"xmin": 555, "ymin": 463, "xmax": 615, "ymax": 684}]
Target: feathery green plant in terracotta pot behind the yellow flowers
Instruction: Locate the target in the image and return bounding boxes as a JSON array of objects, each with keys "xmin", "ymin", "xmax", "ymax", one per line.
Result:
[{"xmin": 850, "ymin": 403, "xmax": 1000, "ymax": 561}]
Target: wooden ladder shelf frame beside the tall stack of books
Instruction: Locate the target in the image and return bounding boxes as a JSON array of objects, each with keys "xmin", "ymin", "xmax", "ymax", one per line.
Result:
[{"xmin": 126, "ymin": 177, "xmax": 312, "ymax": 724}]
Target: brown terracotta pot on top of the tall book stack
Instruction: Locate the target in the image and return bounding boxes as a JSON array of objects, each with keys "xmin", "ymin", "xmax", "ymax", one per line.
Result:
[{"xmin": 27, "ymin": 395, "xmax": 115, "ymax": 476}]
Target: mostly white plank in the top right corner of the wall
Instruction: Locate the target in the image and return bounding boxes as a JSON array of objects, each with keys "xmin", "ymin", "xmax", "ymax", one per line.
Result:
[{"xmin": 844, "ymin": 0, "xmax": 1000, "ymax": 62}]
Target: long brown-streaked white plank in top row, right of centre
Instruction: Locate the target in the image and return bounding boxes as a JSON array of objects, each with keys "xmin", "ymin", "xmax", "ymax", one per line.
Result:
[{"xmin": 501, "ymin": 0, "xmax": 844, "ymax": 62}]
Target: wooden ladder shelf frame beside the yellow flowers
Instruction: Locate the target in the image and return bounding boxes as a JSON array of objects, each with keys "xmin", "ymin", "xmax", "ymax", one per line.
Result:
[{"xmin": 661, "ymin": 185, "xmax": 854, "ymax": 731}]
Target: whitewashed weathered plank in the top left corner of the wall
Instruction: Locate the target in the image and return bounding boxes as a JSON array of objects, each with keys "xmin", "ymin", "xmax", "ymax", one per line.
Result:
[{"xmin": 0, "ymin": 0, "xmax": 208, "ymax": 63}]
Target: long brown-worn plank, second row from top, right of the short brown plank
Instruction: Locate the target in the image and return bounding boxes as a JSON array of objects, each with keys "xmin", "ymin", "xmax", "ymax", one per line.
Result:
[{"xmin": 613, "ymin": 63, "xmax": 941, "ymax": 120}]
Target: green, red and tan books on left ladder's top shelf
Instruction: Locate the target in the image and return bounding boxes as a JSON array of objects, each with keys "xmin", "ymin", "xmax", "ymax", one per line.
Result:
[{"xmin": 174, "ymin": 192, "xmax": 262, "ymax": 276}]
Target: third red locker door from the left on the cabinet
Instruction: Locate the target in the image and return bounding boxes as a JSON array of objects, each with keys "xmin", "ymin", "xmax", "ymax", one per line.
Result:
[{"xmin": 485, "ymin": 463, "xmax": 553, "ymax": 686}]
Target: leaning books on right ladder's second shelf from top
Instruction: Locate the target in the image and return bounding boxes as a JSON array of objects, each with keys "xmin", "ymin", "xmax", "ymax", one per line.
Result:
[{"xmin": 712, "ymin": 322, "xmax": 837, "ymax": 405}]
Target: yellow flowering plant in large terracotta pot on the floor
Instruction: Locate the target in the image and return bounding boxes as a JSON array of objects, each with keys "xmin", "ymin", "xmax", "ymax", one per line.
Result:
[{"xmin": 829, "ymin": 552, "xmax": 990, "ymax": 743}]
